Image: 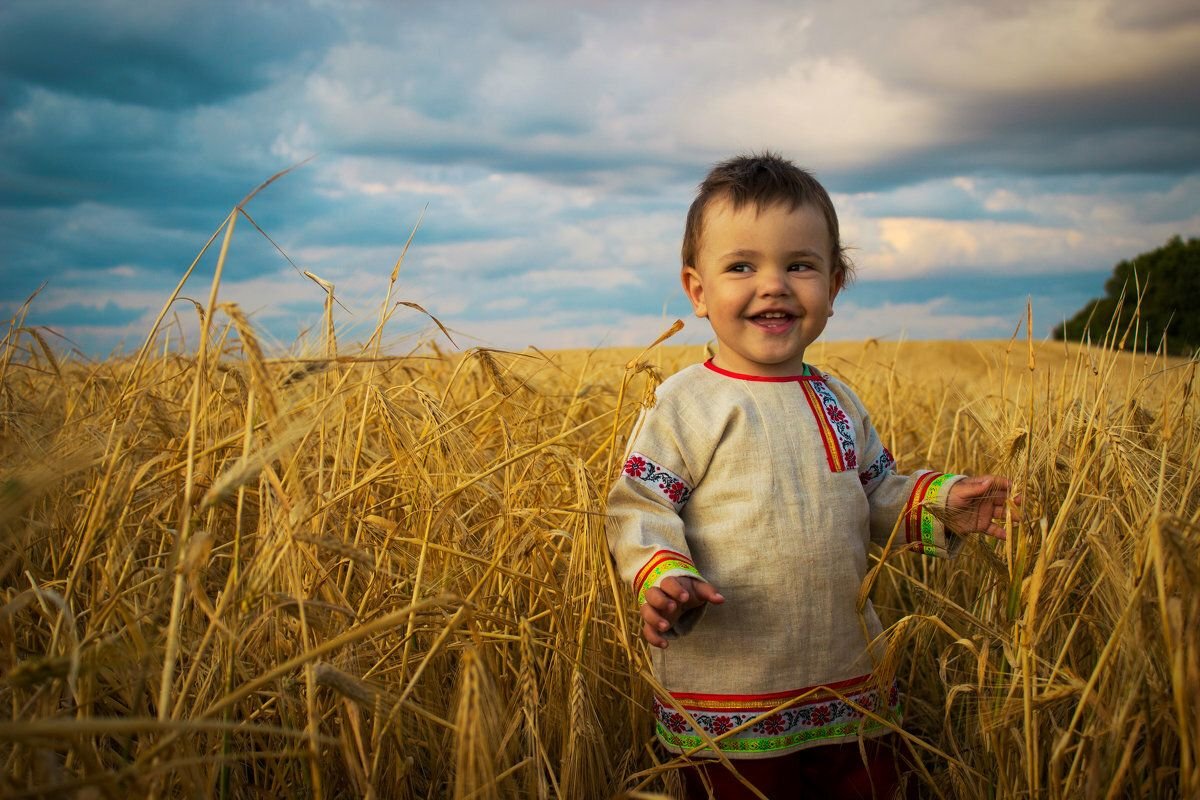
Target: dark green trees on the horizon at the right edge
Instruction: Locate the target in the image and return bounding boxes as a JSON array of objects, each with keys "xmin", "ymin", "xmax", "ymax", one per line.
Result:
[{"xmin": 1054, "ymin": 236, "xmax": 1200, "ymax": 355}]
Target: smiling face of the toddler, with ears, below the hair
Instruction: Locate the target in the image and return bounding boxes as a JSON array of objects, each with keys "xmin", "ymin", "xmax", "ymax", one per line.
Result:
[{"xmin": 682, "ymin": 198, "xmax": 842, "ymax": 377}]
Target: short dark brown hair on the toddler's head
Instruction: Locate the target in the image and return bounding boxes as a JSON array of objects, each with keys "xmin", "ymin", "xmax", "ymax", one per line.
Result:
[{"xmin": 682, "ymin": 151, "xmax": 854, "ymax": 283}]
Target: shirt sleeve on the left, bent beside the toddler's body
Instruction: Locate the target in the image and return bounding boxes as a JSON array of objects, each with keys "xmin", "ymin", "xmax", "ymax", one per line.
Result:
[{"xmin": 605, "ymin": 398, "xmax": 703, "ymax": 634}]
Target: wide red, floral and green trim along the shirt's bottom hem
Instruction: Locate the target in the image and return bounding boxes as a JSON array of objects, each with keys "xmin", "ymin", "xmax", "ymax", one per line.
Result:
[{"xmin": 654, "ymin": 675, "xmax": 900, "ymax": 754}]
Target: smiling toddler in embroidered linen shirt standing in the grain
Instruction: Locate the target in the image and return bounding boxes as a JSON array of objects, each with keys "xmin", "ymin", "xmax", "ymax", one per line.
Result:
[{"xmin": 608, "ymin": 154, "xmax": 1009, "ymax": 798}]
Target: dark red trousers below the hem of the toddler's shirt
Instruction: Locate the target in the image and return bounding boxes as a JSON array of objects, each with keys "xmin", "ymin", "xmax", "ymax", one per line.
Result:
[{"xmin": 683, "ymin": 735, "xmax": 900, "ymax": 800}]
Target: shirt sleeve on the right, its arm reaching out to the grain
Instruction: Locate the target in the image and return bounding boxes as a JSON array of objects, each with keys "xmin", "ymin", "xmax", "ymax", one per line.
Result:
[{"xmin": 847, "ymin": 376, "xmax": 964, "ymax": 557}]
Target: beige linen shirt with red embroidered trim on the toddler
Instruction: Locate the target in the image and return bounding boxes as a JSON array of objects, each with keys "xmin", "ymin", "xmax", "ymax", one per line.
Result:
[{"xmin": 607, "ymin": 362, "xmax": 958, "ymax": 758}]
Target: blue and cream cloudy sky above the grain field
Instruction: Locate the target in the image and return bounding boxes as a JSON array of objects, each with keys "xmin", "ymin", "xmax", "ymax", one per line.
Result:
[{"xmin": 0, "ymin": 0, "xmax": 1200, "ymax": 355}]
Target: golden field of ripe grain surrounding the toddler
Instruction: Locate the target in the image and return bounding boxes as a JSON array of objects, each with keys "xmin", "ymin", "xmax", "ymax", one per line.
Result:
[{"xmin": 0, "ymin": 289, "xmax": 1200, "ymax": 799}]
